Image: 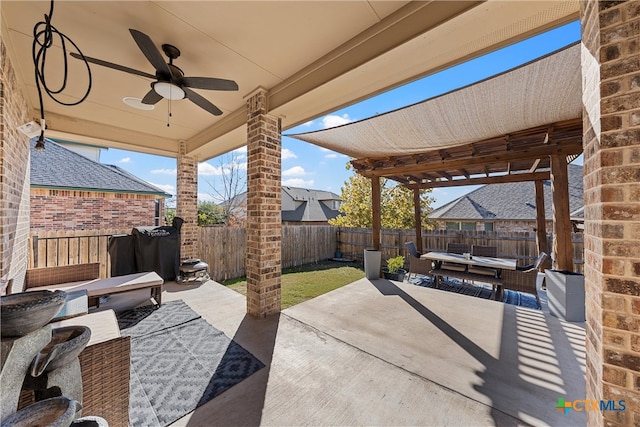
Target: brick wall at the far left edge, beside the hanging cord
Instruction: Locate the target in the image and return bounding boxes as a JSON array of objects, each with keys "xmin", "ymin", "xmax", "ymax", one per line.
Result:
[{"xmin": 0, "ymin": 39, "xmax": 31, "ymax": 293}]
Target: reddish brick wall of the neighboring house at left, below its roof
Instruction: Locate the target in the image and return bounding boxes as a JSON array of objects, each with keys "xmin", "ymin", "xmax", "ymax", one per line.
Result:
[{"xmin": 31, "ymin": 189, "xmax": 164, "ymax": 230}]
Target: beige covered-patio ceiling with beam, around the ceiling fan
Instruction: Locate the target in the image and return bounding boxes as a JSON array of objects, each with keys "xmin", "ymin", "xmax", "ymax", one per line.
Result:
[{"xmin": 0, "ymin": 0, "xmax": 579, "ymax": 161}]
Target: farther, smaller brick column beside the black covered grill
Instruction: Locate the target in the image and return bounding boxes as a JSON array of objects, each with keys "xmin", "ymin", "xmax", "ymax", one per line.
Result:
[{"xmin": 176, "ymin": 141, "xmax": 198, "ymax": 260}]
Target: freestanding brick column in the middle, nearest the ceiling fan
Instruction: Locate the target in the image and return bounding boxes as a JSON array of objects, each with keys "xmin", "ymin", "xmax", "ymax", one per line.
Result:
[{"xmin": 247, "ymin": 89, "xmax": 282, "ymax": 318}]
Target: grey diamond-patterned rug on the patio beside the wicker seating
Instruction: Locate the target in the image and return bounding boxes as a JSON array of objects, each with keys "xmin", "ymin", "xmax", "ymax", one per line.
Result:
[{"xmin": 118, "ymin": 300, "xmax": 264, "ymax": 427}]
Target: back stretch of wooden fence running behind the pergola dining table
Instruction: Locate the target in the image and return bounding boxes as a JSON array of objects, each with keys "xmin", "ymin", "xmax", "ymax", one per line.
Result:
[{"xmin": 338, "ymin": 228, "xmax": 584, "ymax": 273}]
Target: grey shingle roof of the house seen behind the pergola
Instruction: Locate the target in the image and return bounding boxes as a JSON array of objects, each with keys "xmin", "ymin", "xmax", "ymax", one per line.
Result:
[{"xmin": 430, "ymin": 164, "xmax": 584, "ymax": 220}]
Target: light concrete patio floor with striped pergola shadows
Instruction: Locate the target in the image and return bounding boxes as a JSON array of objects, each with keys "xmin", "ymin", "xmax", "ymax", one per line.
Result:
[{"xmin": 163, "ymin": 279, "xmax": 586, "ymax": 426}]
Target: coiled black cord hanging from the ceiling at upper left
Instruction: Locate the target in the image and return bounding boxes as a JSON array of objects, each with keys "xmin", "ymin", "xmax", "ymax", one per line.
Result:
[{"xmin": 32, "ymin": 0, "xmax": 92, "ymax": 149}]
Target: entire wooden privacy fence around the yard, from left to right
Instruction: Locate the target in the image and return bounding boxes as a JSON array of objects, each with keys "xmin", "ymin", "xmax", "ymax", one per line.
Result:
[{"xmin": 29, "ymin": 225, "xmax": 584, "ymax": 281}]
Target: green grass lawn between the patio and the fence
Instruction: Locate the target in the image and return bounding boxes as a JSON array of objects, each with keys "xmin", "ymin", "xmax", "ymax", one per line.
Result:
[{"xmin": 222, "ymin": 261, "xmax": 364, "ymax": 310}]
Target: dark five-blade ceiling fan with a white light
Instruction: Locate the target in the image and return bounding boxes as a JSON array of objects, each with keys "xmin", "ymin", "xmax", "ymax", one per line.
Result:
[{"xmin": 71, "ymin": 29, "xmax": 238, "ymax": 116}]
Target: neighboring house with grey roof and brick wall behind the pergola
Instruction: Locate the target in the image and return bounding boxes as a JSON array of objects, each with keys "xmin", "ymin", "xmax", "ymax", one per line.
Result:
[{"xmin": 429, "ymin": 164, "xmax": 584, "ymax": 232}]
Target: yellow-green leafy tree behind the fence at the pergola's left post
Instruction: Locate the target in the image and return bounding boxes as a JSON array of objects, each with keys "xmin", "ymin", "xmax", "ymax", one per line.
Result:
[{"xmin": 329, "ymin": 163, "xmax": 434, "ymax": 229}]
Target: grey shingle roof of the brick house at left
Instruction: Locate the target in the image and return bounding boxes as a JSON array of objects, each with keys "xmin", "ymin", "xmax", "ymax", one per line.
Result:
[{"xmin": 31, "ymin": 138, "xmax": 170, "ymax": 197}]
